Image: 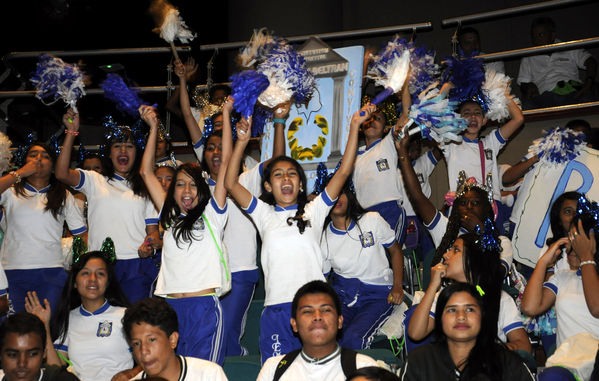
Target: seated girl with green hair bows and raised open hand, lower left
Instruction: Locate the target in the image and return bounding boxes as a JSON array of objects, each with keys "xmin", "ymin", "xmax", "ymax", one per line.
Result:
[{"xmin": 25, "ymin": 251, "xmax": 136, "ymax": 381}]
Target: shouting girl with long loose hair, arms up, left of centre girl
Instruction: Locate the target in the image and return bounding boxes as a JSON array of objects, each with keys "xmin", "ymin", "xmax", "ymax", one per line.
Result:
[{"xmin": 140, "ymin": 102, "xmax": 232, "ymax": 364}]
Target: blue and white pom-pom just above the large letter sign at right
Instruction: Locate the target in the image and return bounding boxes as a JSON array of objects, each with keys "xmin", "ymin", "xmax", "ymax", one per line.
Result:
[{"xmin": 528, "ymin": 127, "xmax": 585, "ymax": 165}]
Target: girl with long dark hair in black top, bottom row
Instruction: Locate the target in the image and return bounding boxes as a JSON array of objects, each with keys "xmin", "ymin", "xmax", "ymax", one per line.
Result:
[{"xmin": 401, "ymin": 283, "xmax": 534, "ymax": 381}]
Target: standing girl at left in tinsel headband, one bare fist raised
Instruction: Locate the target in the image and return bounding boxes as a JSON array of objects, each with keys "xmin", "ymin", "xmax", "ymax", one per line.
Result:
[{"xmin": 56, "ymin": 110, "xmax": 161, "ymax": 302}]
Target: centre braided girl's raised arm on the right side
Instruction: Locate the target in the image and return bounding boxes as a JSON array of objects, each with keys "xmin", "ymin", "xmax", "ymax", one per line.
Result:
[{"xmin": 325, "ymin": 104, "xmax": 376, "ymax": 200}]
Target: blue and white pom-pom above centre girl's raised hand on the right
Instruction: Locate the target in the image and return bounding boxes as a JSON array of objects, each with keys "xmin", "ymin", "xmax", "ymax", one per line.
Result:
[{"xmin": 367, "ymin": 45, "xmax": 410, "ymax": 105}]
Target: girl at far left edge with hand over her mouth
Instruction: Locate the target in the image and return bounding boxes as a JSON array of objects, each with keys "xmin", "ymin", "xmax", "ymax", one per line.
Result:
[{"xmin": 0, "ymin": 143, "xmax": 87, "ymax": 311}]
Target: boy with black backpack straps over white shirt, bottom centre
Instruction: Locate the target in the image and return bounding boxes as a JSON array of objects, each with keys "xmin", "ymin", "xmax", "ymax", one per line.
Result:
[{"xmin": 257, "ymin": 280, "xmax": 376, "ymax": 381}]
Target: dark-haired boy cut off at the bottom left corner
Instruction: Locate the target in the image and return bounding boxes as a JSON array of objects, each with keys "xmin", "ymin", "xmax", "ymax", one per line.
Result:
[{"xmin": 0, "ymin": 312, "xmax": 79, "ymax": 381}]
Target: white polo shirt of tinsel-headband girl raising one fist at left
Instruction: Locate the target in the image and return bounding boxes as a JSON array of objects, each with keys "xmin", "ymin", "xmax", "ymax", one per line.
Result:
[{"xmin": 74, "ymin": 169, "xmax": 158, "ymax": 260}]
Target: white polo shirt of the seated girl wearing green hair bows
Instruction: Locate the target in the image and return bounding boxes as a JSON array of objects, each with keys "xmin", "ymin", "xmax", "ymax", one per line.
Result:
[{"xmin": 54, "ymin": 301, "xmax": 133, "ymax": 381}]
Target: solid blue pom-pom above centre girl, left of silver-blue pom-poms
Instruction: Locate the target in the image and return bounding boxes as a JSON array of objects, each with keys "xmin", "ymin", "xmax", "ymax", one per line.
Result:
[{"xmin": 230, "ymin": 70, "xmax": 269, "ymax": 118}]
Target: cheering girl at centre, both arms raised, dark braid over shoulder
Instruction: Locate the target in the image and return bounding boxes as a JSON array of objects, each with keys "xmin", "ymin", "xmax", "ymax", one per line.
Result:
[{"xmin": 223, "ymin": 99, "xmax": 376, "ymax": 362}]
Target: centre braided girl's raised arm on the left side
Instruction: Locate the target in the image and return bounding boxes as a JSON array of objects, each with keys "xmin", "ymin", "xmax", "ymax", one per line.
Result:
[{"xmin": 224, "ymin": 97, "xmax": 253, "ymax": 208}]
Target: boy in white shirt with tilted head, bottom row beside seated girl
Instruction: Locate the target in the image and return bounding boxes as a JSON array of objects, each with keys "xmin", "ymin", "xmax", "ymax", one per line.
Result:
[{"xmin": 123, "ymin": 298, "xmax": 227, "ymax": 381}]
